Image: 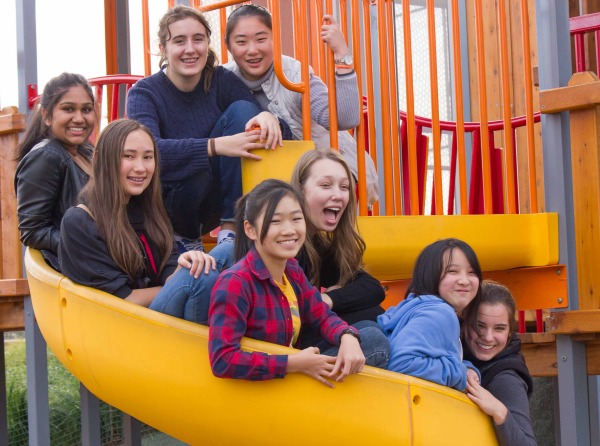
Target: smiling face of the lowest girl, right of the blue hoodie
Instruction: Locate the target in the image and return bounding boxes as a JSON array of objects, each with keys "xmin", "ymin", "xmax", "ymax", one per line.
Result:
[{"xmin": 466, "ymin": 303, "xmax": 511, "ymax": 361}]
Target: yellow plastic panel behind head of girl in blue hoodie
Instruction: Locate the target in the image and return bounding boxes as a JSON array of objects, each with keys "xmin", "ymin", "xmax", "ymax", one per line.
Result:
[{"xmin": 358, "ymin": 213, "xmax": 558, "ymax": 280}]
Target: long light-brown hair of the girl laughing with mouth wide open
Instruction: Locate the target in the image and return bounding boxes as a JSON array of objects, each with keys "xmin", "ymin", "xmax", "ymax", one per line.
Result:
[{"xmin": 291, "ymin": 148, "xmax": 366, "ymax": 286}]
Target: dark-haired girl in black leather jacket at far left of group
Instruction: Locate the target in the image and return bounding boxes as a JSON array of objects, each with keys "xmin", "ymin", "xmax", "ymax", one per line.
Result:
[{"xmin": 15, "ymin": 73, "xmax": 97, "ymax": 270}]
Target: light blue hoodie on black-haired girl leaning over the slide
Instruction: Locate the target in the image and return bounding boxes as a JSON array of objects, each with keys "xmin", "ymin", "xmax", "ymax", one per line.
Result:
[{"xmin": 377, "ymin": 294, "xmax": 479, "ymax": 391}]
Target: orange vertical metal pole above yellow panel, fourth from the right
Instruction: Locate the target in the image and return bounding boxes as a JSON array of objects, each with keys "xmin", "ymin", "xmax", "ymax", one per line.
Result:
[{"xmin": 427, "ymin": 0, "xmax": 444, "ymax": 215}]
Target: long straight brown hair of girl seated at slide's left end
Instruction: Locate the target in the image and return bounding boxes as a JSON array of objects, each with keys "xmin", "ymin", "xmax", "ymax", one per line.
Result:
[{"xmin": 81, "ymin": 119, "xmax": 173, "ymax": 277}]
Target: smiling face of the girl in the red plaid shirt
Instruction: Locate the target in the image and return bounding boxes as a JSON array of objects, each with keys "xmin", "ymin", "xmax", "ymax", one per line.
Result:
[{"xmin": 244, "ymin": 195, "xmax": 306, "ymax": 266}]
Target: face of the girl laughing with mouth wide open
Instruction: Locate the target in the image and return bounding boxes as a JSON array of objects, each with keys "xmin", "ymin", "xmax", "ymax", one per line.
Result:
[{"xmin": 302, "ymin": 159, "xmax": 351, "ymax": 232}]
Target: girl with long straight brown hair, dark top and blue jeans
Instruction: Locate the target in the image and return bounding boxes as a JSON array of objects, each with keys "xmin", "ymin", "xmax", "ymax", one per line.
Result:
[{"xmin": 59, "ymin": 119, "xmax": 223, "ymax": 322}]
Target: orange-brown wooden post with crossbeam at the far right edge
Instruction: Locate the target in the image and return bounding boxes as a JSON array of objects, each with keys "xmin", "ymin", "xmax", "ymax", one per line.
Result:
[{"xmin": 540, "ymin": 71, "xmax": 600, "ymax": 310}]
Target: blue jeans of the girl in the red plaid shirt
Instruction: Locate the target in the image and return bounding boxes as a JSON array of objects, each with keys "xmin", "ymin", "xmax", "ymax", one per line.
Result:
[{"xmin": 317, "ymin": 321, "xmax": 390, "ymax": 369}]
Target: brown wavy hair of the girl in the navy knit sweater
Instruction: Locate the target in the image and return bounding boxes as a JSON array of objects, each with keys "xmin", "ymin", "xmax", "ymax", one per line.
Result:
[{"xmin": 158, "ymin": 5, "xmax": 219, "ymax": 91}]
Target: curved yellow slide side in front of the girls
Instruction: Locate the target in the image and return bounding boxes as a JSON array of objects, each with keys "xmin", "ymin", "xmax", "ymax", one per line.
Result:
[{"xmin": 25, "ymin": 249, "xmax": 497, "ymax": 446}]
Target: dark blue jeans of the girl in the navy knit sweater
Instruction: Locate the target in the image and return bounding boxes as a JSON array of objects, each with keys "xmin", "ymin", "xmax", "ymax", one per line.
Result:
[{"xmin": 163, "ymin": 101, "xmax": 261, "ymax": 240}]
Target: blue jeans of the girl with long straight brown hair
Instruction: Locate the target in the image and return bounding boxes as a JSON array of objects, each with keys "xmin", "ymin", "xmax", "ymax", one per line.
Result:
[{"xmin": 150, "ymin": 241, "xmax": 234, "ymax": 324}]
